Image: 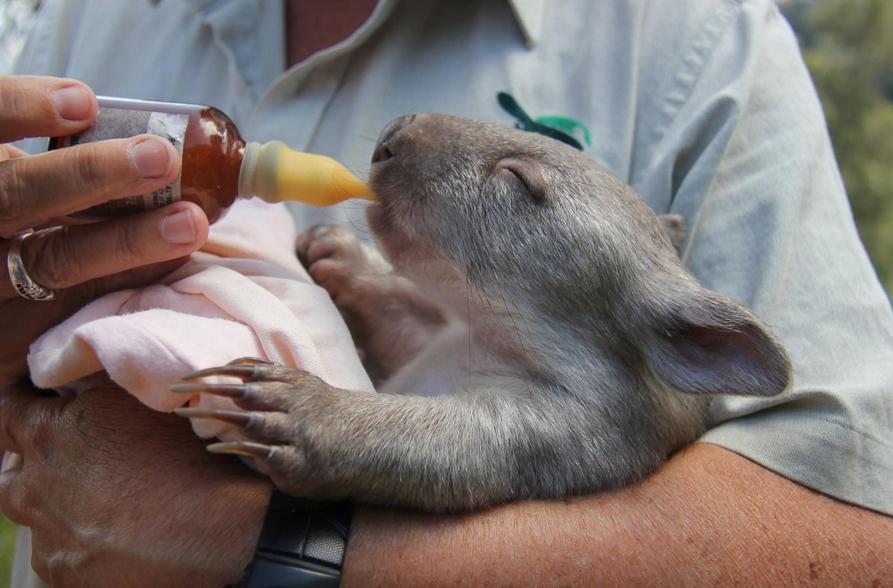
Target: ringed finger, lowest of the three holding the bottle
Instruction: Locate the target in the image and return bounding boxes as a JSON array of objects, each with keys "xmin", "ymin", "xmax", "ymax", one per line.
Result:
[{"xmin": 0, "ymin": 202, "xmax": 208, "ymax": 300}]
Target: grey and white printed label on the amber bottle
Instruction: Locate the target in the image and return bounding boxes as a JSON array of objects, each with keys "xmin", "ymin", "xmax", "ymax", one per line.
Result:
[{"xmin": 50, "ymin": 108, "xmax": 189, "ymax": 218}]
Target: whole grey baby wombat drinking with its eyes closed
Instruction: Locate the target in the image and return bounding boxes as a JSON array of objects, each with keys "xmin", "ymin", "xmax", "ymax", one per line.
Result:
[{"xmin": 178, "ymin": 114, "xmax": 791, "ymax": 511}]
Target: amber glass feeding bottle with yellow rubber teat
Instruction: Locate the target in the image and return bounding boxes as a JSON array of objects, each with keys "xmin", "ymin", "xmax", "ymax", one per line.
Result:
[{"xmin": 50, "ymin": 96, "xmax": 375, "ymax": 222}]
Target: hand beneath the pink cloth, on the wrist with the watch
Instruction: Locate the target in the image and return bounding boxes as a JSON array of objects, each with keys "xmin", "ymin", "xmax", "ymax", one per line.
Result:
[{"xmin": 0, "ymin": 385, "xmax": 270, "ymax": 587}]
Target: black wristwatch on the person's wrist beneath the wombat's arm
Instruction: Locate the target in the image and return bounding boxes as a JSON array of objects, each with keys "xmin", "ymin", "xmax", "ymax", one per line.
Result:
[{"xmin": 236, "ymin": 488, "xmax": 353, "ymax": 588}]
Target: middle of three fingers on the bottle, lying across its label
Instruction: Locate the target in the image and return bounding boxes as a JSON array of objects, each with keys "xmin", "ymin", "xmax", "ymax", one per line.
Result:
[{"xmin": 0, "ymin": 135, "xmax": 180, "ymax": 235}]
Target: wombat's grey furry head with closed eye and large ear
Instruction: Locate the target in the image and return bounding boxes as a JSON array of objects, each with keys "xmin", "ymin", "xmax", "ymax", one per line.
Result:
[{"xmin": 368, "ymin": 114, "xmax": 790, "ymax": 395}]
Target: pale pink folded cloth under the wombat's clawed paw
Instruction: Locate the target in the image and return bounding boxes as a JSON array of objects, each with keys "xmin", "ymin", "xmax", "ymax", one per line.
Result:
[{"xmin": 28, "ymin": 200, "xmax": 373, "ymax": 437}]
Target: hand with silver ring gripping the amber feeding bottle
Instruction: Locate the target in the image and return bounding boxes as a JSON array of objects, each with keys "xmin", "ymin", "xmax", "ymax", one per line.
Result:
[{"xmin": 0, "ymin": 76, "xmax": 208, "ymax": 384}]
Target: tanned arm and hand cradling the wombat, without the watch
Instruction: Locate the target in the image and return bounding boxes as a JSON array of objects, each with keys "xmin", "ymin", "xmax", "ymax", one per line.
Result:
[{"xmin": 0, "ymin": 388, "xmax": 893, "ymax": 588}]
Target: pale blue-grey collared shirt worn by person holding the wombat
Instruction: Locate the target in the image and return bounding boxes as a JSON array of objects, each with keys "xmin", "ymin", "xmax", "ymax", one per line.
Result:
[{"xmin": 8, "ymin": 0, "xmax": 893, "ymax": 580}]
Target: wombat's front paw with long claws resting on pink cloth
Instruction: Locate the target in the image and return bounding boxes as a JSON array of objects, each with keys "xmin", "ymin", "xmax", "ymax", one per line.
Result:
[{"xmin": 171, "ymin": 359, "xmax": 338, "ymax": 498}]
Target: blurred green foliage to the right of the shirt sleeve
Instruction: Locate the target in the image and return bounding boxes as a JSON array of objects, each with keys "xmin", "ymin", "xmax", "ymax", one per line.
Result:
[{"xmin": 785, "ymin": 0, "xmax": 893, "ymax": 295}]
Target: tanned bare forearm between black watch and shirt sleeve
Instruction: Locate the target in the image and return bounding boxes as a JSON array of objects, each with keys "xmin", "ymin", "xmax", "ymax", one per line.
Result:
[{"xmin": 344, "ymin": 444, "xmax": 893, "ymax": 586}]
